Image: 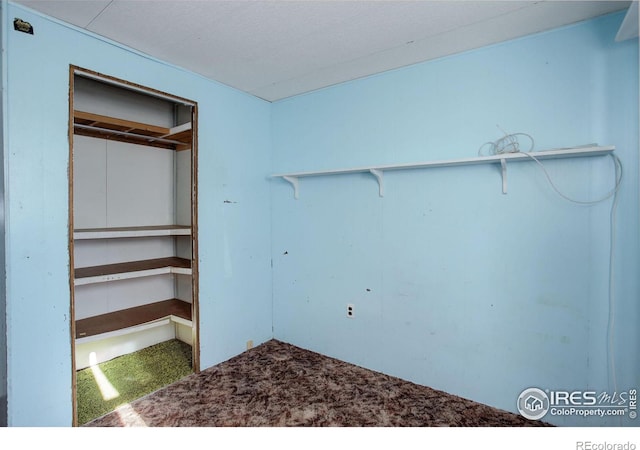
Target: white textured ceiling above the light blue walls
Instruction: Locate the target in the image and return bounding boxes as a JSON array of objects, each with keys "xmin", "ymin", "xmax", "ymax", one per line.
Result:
[{"xmin": 15, "ymin": 0, "xmax": 630, "ymax": 101}]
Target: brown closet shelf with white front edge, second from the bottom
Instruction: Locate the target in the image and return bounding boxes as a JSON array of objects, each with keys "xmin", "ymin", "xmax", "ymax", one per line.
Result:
[{"xmin": 74, "ymin": 257, "xmax": 191, "ymax": 286}]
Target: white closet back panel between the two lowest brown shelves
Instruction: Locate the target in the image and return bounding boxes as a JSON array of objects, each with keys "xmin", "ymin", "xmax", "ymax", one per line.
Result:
[{"xmin": 75, "ymin": 275, "xmax": 175, "ymax": 320}]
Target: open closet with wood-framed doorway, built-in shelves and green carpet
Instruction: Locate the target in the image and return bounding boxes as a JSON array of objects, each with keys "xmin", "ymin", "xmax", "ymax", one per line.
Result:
[{"xmin": 69, "ymin": 66, "xmax": 199, "ymax": 425}]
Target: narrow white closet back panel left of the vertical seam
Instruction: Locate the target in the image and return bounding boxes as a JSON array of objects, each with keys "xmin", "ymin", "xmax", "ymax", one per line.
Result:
[{"xmin": 73, "ymin": 136, "xmax": 107, "ymax": 228}]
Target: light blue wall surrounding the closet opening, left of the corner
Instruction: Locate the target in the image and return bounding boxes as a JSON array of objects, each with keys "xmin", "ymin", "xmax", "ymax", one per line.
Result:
[{"xmin": 4, "ymin": 4, "xmax": 272, "ymax": 426}]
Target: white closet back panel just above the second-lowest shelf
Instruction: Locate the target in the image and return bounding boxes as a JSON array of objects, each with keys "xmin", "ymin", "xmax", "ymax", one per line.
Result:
[{"xmin": 74, "ymin": 237, "xmax": 175, "ymax": 267}]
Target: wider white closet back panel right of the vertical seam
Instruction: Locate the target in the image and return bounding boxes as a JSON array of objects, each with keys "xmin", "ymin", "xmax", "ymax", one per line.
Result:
[{"xmin": 107, "ymin": 141, "xmax": 175, "ymax": 227}]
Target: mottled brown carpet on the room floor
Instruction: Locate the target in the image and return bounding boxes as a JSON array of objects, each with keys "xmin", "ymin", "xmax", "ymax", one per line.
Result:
[{"xmin": 85, "ymin": 340, "xmax": 549, "ymax": 427}]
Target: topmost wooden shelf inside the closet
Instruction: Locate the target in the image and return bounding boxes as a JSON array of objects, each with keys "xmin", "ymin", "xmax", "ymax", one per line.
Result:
[{"xmin": 73, "ymin": 110, "xmax": 192, "ymax": 150}]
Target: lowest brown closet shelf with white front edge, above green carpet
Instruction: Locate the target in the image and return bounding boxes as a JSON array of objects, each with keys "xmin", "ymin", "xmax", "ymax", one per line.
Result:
[{"xmin": 76, "ymin": 298, "xmax": 192, "ymax": 342}]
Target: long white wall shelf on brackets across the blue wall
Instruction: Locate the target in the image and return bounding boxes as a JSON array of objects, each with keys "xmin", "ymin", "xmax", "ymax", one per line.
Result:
[{"xmin": 271, "ymin": 145, "xmax": 615, "ymax": 199}]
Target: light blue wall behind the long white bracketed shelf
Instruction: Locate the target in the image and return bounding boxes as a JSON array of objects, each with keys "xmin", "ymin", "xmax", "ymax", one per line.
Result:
[{"xmin": 272, "ymin": 9, "xmax": 640, "ymax": 425}]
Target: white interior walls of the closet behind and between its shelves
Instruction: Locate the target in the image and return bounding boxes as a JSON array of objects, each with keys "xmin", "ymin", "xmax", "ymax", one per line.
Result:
[{"xmin": 73, "ymin": 76, "xmax": 192, "ymax": 368}]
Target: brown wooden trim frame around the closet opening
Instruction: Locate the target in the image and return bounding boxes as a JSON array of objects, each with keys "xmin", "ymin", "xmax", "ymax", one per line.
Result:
[{"xmin": 68, "ymin": 65, "xmax": 200, "ymax": 426}]
